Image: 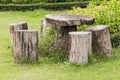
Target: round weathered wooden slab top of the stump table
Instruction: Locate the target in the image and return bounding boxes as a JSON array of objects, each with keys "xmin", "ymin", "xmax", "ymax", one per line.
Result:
[{"xmin": 45, "ymin": 14, "xmax": 94, "ymax": 26}]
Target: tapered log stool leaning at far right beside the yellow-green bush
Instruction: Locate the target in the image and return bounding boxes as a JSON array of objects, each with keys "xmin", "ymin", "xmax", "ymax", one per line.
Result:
[{"xmin": 86, "ymin": 25, "xmax": 112, "ymax": 57}]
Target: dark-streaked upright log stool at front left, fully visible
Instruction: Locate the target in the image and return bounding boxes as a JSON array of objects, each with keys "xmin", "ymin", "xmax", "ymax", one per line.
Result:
[{"xmin": 13, "ymin": 30, "xmax": 38, "ymax": 62}]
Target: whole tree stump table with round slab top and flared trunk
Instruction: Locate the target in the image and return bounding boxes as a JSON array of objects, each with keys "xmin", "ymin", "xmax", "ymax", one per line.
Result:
[{"xmin": 45, "ymin": 14, "xmax": 94, "ymax": 52}]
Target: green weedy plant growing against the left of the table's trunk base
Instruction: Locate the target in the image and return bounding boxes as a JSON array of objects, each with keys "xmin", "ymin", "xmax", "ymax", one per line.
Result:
[{"xmin": 39, "ymin": 27, "xmax": 68, "ymax": 62}]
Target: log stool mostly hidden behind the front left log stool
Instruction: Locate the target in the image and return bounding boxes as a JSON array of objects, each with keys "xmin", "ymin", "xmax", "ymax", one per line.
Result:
[{"xmin": 9, "ymin": 22, "xmax": 28, "ymax": 45}]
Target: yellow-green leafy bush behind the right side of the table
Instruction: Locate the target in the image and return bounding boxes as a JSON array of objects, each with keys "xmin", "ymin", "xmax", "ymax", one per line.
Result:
[{"xmin": 70, "ymin": 0, "xmax": 120, "ymax": 33}]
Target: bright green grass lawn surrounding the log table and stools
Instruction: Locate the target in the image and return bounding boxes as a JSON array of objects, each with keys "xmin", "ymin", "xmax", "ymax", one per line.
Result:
[{"xmin": 0, "ymin": 10, "xmax": 120, "ymax": 80}]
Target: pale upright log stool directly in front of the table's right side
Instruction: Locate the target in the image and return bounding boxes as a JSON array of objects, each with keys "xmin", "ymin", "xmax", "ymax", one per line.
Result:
[{"xmin": 68, "ymin": 32, "xmax": 92, "ymax": 64}]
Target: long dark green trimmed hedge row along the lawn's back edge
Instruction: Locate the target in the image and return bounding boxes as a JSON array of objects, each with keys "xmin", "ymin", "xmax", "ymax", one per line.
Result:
[{"xmin": 0, "ymin": 1, "xmax": 89, "ymax": 11}]
